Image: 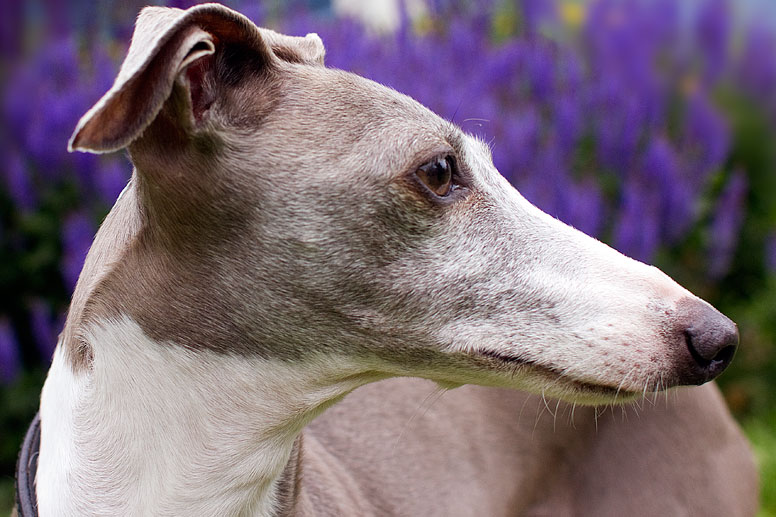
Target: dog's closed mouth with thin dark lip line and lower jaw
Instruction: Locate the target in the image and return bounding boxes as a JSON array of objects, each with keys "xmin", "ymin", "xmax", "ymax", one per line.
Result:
[{"xmin": 472, "ymin": 350, "xmax": 642, "ymax": 403}]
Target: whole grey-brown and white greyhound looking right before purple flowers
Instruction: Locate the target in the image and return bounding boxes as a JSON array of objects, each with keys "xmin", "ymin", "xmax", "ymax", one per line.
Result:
[{"xmin": 20, "ymin": 4, "xmax": 757, "ymax": 516}]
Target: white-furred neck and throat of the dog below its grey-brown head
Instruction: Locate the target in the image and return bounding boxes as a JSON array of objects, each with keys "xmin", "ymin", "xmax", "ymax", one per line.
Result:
[{"xmin": 37, "ymin": 318, "xmax": 377, "ymax": 516}]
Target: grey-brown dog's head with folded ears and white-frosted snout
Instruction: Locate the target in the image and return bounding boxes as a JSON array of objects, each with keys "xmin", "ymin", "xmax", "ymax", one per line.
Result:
[{"xmin": 65, "ymin": 4, "xmax": 738, "ymax": 403}]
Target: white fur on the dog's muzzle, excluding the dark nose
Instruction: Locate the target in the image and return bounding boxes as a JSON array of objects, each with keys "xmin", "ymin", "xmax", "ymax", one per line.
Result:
[{"xmin": 430, "ymin": 138, "xmax": 702, "ymax": 403}]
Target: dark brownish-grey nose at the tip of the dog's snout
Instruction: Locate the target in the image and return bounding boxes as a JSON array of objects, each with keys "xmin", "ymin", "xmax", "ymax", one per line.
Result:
[{"xmin": 677, "ymin": 299, "xmax": 738, "ymax": 384}]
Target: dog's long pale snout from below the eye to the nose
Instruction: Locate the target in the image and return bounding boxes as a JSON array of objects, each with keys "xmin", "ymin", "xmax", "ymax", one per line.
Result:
[{"xmin": 435, "ymin": 136, "xmax": 738, "ymax": 403}]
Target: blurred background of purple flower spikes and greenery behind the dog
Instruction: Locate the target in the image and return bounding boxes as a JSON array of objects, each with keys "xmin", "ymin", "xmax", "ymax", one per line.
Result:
[{"xmin": 0, "ymin": 0, "xmax": 776, "ymax": 515}]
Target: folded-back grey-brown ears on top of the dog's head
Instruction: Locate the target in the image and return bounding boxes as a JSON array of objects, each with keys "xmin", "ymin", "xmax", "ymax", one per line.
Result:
[{"xmin": 68, "ymin": 4, "xmax": 324, "ymax": 153}]
